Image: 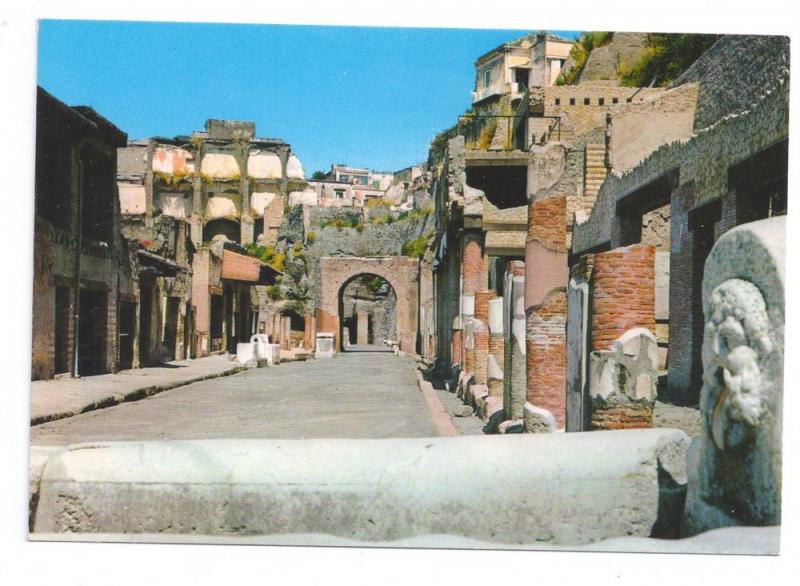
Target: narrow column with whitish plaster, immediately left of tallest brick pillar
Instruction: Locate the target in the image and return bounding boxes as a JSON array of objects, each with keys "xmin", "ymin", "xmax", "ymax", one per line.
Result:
[{"xmin": 503, "ymin": 261, "xmax": 526, "ymax": 420}]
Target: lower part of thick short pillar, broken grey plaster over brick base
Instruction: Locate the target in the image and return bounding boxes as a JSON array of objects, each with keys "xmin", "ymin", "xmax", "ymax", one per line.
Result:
[{"xmin": 589, "ymin": 328, "xmax": 658, "ymax": 430}]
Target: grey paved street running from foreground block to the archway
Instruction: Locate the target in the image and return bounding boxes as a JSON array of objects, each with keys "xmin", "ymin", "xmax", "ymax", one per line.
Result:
[{"xmin": 31, "ymin": 353, "xmax": 438, "ymax": 445}]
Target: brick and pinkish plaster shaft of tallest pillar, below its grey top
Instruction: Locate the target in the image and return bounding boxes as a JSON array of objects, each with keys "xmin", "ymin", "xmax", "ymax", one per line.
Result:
[{"xmin": 525, "ymin": 196, "xmax": 568, "ymax": 430}]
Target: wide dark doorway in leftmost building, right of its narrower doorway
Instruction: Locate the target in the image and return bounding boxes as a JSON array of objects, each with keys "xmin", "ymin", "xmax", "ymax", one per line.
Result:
[{"xmin": 78, "ymin": 289, "xmax": 108, "ymax": 376}]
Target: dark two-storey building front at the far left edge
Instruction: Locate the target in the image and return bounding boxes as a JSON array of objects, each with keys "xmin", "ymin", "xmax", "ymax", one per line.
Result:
[{"xmin": 31, "ymin": 88, "xmax": 132, "ymax": 380}]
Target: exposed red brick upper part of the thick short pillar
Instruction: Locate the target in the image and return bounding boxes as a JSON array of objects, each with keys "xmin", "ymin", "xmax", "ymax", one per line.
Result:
[{"xmin": 592, "ymin": 244, "xmax": 656, "ymax": 350}]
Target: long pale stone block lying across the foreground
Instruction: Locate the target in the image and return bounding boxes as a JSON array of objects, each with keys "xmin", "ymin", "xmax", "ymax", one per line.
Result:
[{"xmin": 32, "ymin": 429, "xmax": 689, "ymax": 545}]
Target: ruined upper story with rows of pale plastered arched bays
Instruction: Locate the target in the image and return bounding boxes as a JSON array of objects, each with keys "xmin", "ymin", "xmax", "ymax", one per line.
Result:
[{"xmin": 117, "ymin": 119, "xmax": 306, "ymax": 234}]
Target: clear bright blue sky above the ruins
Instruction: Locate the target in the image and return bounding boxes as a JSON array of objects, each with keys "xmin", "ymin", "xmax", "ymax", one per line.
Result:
[{"xmin": 38, "ymin": 20, "xmax": 576, "ymax": 175}]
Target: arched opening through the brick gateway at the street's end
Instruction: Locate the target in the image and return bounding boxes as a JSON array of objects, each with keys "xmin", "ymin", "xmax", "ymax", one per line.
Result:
[{"xmin": 338, "ymin": 273, "xmax": 397, "ymax": 351}]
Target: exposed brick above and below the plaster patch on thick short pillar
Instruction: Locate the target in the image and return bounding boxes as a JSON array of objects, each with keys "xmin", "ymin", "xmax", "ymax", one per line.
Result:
[{"xmin": 590, "ymin": 244, "xmax": 656, "ymax": 430}]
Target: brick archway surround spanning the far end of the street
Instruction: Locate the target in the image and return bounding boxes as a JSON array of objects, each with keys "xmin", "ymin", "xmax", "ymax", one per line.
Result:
[{"xmin": 316, "ymin": 256, "xmax": 419, "ymax": 352}]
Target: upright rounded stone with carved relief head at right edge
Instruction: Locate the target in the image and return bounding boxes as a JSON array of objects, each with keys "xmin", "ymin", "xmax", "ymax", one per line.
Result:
[{"xmin": 683, "ymin": 217, "xmax": 786, "ymax": 535}]
